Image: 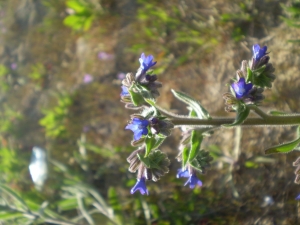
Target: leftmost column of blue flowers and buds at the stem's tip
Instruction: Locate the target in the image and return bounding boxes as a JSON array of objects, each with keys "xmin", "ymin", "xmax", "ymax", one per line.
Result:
[{"xmin": 120, "ymin": 53, "xmax": 174, "ymax": 195}]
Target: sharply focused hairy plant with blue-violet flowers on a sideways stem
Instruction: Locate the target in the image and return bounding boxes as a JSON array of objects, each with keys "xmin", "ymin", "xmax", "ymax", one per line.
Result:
[{"xmin": 121, "ymin": 48, "xmax": 300, "ymax": 195}]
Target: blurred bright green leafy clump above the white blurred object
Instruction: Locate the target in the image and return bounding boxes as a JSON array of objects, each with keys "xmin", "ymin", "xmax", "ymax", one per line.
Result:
[{"xmin": 39, "ymin": 95, "xmax": 72, "ymax": 137}]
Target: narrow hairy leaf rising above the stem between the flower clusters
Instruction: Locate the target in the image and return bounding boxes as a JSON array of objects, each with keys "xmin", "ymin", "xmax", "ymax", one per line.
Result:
[{"xmin": 171, "ymin": 90, "xmax": 211, "ymax": 119}]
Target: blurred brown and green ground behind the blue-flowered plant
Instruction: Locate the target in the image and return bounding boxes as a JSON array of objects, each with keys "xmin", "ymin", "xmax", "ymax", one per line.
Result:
[{"xmin": 0, "ymin": 0, "xmax": 300, "ymax": 225}]
